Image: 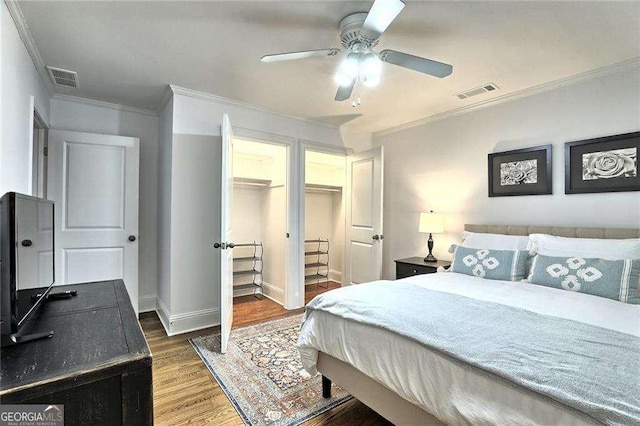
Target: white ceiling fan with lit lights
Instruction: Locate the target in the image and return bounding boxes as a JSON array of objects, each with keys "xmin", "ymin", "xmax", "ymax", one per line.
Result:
[{"xmin": 260, "ymin": 0, "xmax": 453, "ymax": 106}]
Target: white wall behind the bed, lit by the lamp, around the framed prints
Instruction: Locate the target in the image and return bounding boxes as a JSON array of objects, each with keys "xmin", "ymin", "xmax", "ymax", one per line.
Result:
[{"xmin": 374, "ymin": 69, "xmax": 640, "ymax": 278}]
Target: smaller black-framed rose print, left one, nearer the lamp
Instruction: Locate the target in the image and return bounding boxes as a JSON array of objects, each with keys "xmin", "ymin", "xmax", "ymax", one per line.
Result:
[{"xmin": 489, "ymin": 145, "xmax": 552, "ymax": 197}]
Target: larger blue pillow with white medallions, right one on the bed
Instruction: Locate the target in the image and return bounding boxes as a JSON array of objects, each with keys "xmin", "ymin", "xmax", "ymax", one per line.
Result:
[{"xmin": 529, "ymin": 254, "xmax": 640, "ymax": 305}]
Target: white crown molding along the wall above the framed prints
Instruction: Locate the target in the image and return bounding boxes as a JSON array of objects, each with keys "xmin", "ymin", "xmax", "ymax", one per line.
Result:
[{"xmin": 372, "ymin": 57, "xmax": 640, "ymax": 138}]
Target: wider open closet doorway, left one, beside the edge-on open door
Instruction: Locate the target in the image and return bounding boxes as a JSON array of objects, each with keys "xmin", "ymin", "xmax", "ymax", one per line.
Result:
[{"xmin": 231, "ymin": 137, "xmax": 289, "ymax": 326}]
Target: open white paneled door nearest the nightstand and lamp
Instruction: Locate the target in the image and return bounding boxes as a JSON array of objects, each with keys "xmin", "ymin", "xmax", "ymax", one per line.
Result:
[{"xmin": 343, "ymin": 147, "xmax": 384, "ymax": 285}]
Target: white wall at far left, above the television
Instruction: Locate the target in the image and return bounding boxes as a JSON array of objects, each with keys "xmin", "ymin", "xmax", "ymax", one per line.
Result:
[{"xmin": 0, "ymin": 2, "xmax": 50, "ymax": 195}]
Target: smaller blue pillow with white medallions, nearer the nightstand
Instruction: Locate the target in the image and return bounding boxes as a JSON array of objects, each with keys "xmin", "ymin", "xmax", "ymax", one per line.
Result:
[{"xmin": 449, "ymin": 246, "xmax": 528, "ymax": 281}]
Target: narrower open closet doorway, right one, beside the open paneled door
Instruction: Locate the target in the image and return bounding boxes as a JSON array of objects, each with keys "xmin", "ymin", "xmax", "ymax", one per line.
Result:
[{"xmin": 304, "ymin": 149, "xmax": 345, "ymax": 303}]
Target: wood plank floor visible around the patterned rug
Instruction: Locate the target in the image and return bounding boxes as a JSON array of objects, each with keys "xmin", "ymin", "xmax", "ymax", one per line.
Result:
[{"xmin": 140, "ymin": 283, "xmax": 390, "ymax": 426}]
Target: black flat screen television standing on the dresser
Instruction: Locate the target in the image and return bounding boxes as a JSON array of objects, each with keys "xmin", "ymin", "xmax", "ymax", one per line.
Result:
[{"xmin": 0, "ymin": 192, "xmax": 55, "ymax": 345}]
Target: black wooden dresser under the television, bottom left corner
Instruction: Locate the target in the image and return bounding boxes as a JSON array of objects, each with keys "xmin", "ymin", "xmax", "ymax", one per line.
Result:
[{"xmin": 0, "ymin": 280, "xmax": 153, "ymax": 426}]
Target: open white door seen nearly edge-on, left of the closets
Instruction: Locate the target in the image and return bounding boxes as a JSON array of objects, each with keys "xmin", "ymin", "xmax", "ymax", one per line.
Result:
[{"xmin": 219, "ymin": 114, "xmax": 233, "ymax": 353}]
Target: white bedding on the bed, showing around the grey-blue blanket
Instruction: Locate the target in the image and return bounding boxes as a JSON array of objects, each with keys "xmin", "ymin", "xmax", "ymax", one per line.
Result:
[{"xmin": 298, "ymin": 272, "xmax": 640, "ymax": 425}]
